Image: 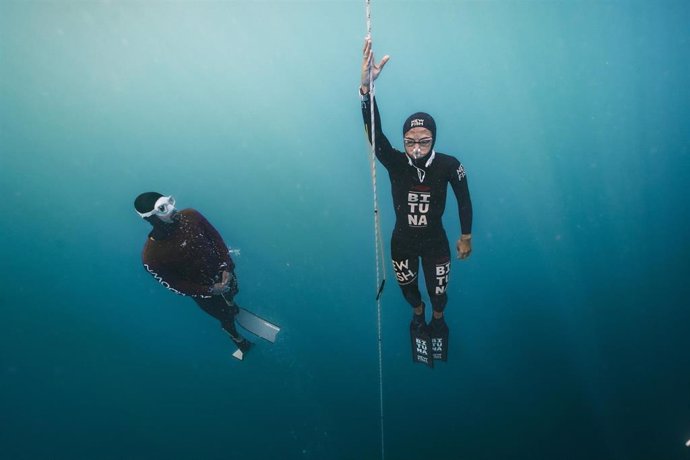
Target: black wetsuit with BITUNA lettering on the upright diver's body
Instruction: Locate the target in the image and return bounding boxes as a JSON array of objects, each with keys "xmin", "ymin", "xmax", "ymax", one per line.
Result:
[{"xmin": 362, "ymin": 91, "xmax": 472, "ymax": 311}]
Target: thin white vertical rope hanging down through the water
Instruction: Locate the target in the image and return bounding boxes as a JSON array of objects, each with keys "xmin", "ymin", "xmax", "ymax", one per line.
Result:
[{"xmin": 365, "ymin": 0, "xmax": 386, "ymax": 460}]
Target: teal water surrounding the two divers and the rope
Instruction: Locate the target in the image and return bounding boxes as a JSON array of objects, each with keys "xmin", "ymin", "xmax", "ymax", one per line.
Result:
[{"xmin": 0, "ymin": 0, "xmax": 690, "ymax": 459}]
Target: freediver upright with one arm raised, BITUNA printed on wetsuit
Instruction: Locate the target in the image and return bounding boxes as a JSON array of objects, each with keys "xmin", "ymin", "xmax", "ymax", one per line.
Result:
[{"xmin": 359, "ymin": 38, "xmax": 472, "ymax": 366}]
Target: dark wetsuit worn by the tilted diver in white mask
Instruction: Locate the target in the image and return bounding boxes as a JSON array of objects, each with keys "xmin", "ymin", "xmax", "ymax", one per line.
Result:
[{"xmin": 141, "ymin": 209, "xmax": 240, "ymax": 341}]
